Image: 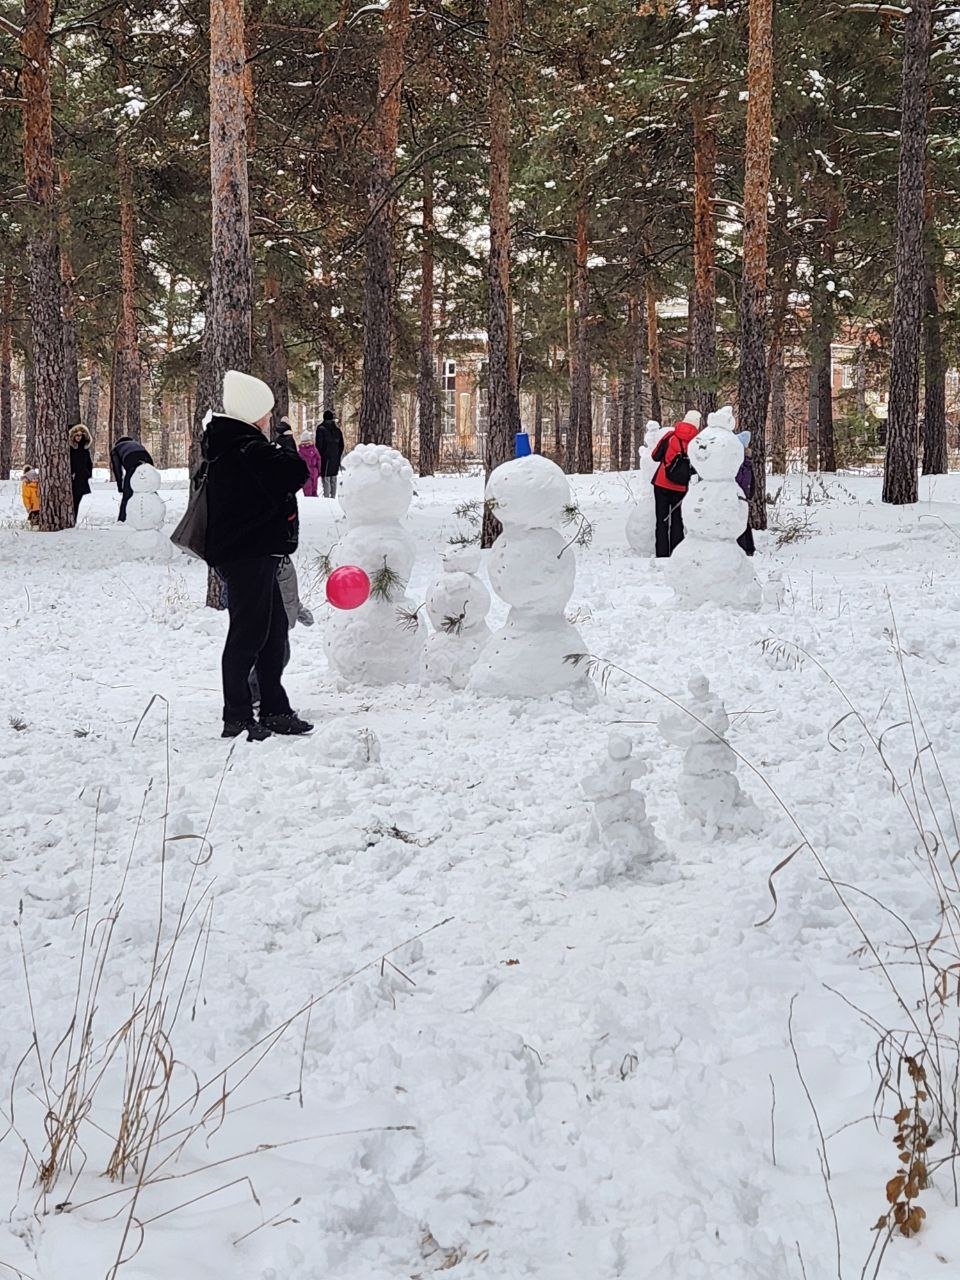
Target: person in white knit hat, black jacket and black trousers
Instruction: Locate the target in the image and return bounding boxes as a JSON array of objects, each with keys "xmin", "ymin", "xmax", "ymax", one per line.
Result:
[{"xmin": 201, "ymin": 369, "xmax": 314, "ymax": 741}]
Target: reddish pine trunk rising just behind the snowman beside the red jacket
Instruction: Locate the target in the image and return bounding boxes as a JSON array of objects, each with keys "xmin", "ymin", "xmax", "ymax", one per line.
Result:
[{"xmin": 737, "ymin": 0, "xmax": 773, "ymax": 529}]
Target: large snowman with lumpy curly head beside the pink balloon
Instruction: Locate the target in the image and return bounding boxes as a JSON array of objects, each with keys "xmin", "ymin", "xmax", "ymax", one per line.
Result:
[{"xmin": 324, "ymin": 444, "xmax": 426, "ymax": 685}]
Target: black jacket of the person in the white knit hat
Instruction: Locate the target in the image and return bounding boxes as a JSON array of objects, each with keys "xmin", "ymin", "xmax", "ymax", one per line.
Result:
[{"xmin": 202, "ymin": 413, "xmax": 310, "ymax": 564}]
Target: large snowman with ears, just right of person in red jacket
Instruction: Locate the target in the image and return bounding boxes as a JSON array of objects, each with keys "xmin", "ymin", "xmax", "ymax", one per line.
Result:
[{"xmin": 669, "ymin": 406, "xmax": 763, "ymax": 609}]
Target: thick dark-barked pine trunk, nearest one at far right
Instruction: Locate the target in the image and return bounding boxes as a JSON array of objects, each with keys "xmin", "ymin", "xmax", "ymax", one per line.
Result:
[{"xmin": 883, "ymin": 0, "xmax": 932, "ymax": 504}]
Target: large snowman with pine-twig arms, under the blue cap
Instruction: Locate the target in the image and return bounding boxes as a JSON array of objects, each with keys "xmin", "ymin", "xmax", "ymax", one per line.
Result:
[{"xmin": 470, "ymin": 453, "xmax": 585, "ymax": 698}]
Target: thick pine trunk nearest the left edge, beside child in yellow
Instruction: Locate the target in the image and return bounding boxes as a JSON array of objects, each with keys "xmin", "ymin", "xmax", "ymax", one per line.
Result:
[{"xmin": 20, "ymin": 0, "xmax": 74, "ymax": 532}]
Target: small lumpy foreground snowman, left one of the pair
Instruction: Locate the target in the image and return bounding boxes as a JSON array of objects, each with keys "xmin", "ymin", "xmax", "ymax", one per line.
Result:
[{"xmin": 580, "ymin": 732, "xmax": 663, "ymax": 883}]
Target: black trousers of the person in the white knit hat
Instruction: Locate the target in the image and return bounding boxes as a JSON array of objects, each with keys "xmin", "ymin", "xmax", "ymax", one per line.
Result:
[{"xmin": 218, "ymin": 556, "xmax": 291, "ymax": 723}]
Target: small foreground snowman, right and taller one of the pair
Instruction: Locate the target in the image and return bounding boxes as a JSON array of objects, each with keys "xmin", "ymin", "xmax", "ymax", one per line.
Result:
[{"xmin": 659, "ymin": 675, "xmax": 760, "ymax": 837}]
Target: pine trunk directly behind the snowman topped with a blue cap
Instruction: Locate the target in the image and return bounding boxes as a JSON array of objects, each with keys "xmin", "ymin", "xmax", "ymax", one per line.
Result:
[{"xmin": 481, "ymin": 0, "xmax": 516, "ymax": 547}]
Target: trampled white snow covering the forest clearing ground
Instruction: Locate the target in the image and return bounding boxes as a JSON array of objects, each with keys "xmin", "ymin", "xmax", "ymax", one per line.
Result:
[{"xmin": 0, "ymin": 472, "xmax": 960, "ymax": 1280}]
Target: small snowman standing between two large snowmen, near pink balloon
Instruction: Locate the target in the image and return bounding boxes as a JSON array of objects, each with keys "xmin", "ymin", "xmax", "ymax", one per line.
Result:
[{"xmin": 422, "ymin": 547, "xmax": 490, "ymax": 689}]
